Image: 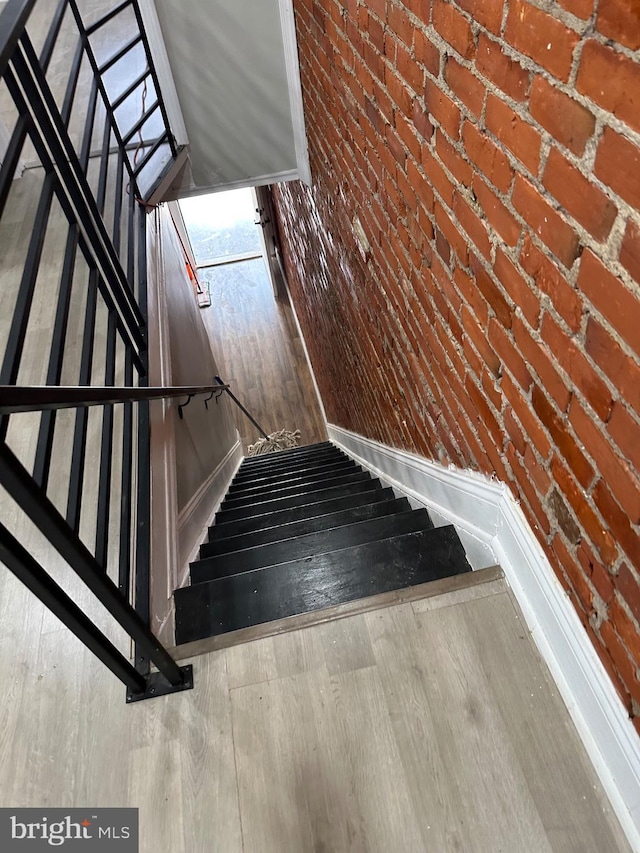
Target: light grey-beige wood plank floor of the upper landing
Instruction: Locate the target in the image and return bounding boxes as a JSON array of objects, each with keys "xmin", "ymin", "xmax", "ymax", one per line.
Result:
[{"xmin": 0, "ymin": 572, "xmax": 629, "ymax": 853}]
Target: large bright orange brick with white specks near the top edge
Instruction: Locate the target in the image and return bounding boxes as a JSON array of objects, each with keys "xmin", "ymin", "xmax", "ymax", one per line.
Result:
[{"xmin": 505, "ymin": 0, "xmax": 579, "ymax": 81}]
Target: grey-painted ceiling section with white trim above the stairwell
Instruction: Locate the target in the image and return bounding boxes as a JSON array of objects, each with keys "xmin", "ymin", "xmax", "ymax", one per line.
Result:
[{"xmin": 143, "ymin": 0, "xmax": 308, "ymax": 196}]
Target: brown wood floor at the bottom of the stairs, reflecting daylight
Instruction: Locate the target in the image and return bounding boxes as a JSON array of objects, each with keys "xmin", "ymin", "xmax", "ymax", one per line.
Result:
[{"xmin": 202, "ymin": 258, "xmax": 327, "ymax": 450}]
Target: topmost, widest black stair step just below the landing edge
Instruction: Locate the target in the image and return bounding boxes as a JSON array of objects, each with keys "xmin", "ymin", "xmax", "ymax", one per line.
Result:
[{"xmin": 175, "ymin": 525, "xmax": 471, "ymax": 645}]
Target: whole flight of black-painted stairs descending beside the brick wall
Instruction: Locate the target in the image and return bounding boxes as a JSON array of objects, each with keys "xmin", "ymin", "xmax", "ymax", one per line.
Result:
[{"xmin": 174, "ymin": 442, "xmax": 471, "ymax": 645}]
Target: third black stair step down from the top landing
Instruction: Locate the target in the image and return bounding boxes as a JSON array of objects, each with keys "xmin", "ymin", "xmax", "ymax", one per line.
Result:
[{"xmin": 200, "ymin": 498, "xmax": 409, "ymax": 559}]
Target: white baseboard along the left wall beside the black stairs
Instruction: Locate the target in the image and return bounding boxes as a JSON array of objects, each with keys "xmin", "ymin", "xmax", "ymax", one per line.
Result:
[{"xmin": 178, "ymin": 438, "xmax": 244, "ymax": 587}]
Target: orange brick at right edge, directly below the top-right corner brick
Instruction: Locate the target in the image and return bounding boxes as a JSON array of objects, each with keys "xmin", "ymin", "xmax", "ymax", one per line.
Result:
[{"xmin": 576, "ymin": 41, "xmax": 640, "ymax": 130}]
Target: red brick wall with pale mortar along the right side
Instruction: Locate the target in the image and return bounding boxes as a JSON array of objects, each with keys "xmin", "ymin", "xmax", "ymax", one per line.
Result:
[{"xmin": 275, "ymin": 0, "xmax": 640, "ymax": 730}]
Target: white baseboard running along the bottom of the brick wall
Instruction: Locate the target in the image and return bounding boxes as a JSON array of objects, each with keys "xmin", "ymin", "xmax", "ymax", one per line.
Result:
[{"xmin": 328, "ymin": 424, "xmax": 640, "ymax": 850}]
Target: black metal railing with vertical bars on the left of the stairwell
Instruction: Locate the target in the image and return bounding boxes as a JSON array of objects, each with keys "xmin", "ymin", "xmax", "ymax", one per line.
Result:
[{"xmin": 0, "ymin": 0, "xmax": 191, "ymax": 699}]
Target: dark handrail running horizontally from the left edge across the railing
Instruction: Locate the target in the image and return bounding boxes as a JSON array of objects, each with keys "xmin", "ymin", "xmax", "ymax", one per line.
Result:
[{"xmin": 0, "ymin": 383, "xmax": 229, "ymax": 420}]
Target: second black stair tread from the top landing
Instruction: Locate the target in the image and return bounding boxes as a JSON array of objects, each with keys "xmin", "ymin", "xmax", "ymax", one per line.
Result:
[{"xmin": 191, "ymin": 509, "xmax": 432, "ymax": 584}]
